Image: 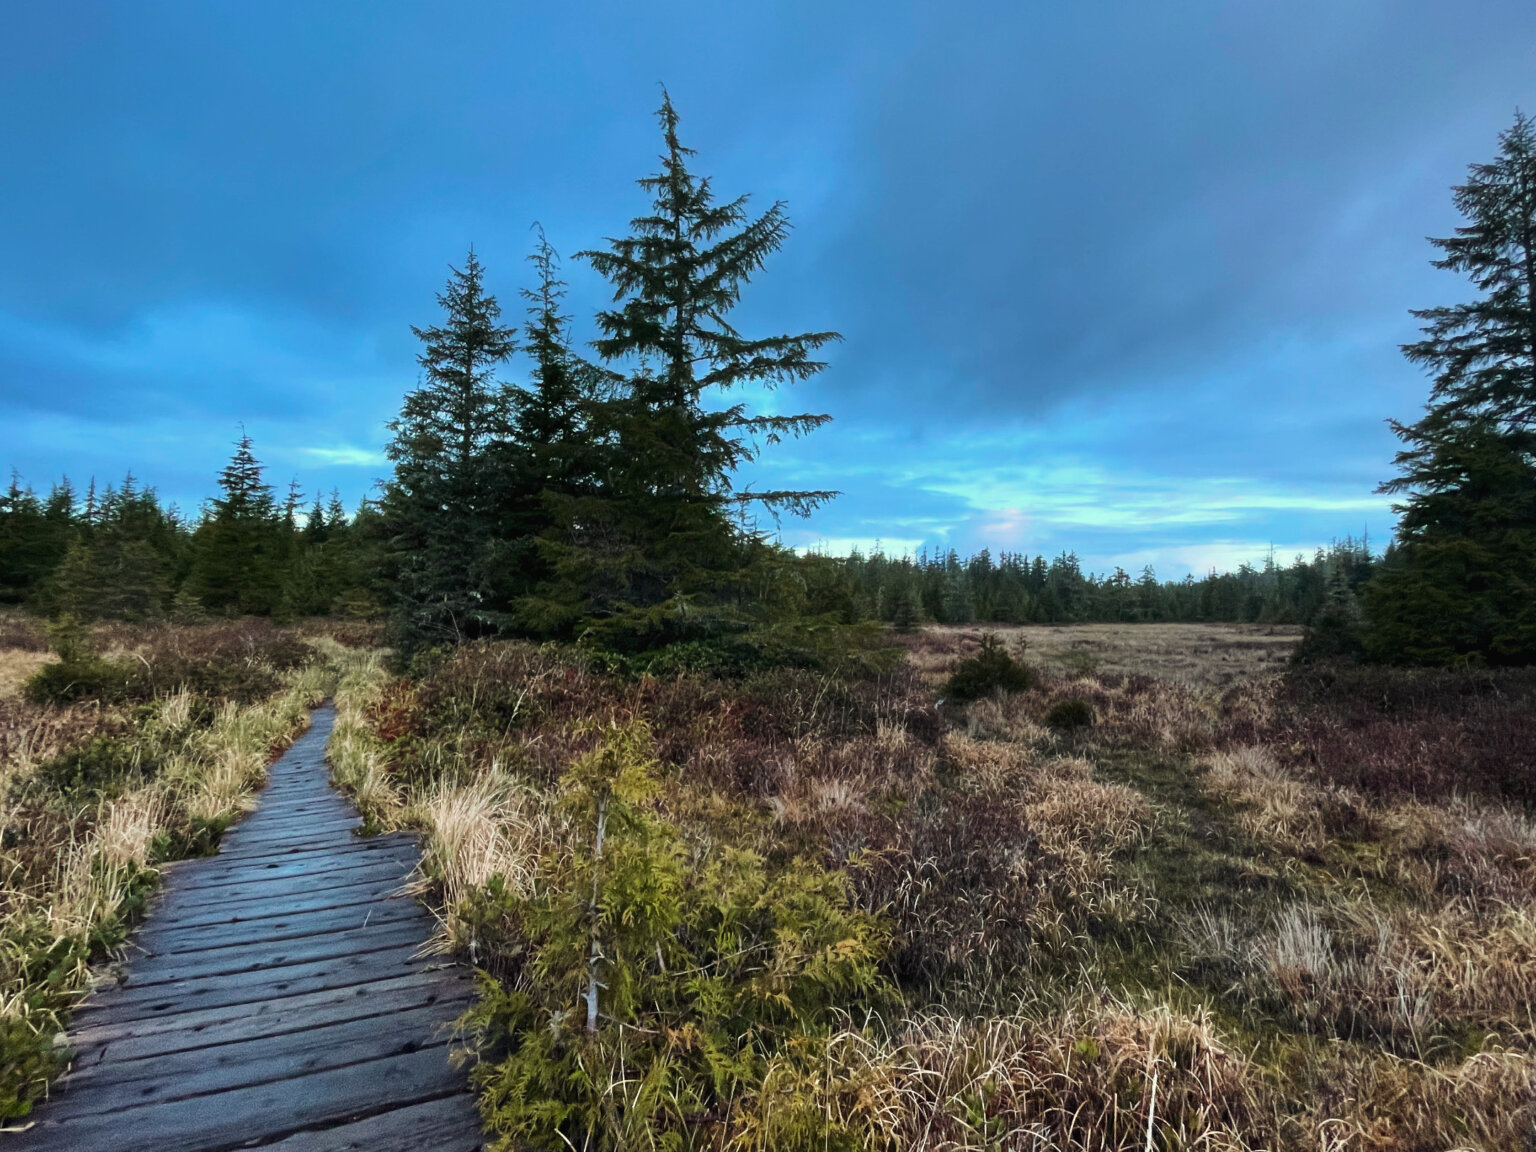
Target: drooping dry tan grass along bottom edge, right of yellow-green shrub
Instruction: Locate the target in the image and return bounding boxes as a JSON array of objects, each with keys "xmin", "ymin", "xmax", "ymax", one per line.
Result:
[{"xmin": 780, "ymin": 1000, "xmax": 1275, "ymax": 1152}]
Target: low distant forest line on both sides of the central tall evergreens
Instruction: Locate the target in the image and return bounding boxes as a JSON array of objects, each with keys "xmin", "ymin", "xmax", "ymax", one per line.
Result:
[{"xmin": 0, "ymin": 451, "xmax": 1379, "ymax": 627}]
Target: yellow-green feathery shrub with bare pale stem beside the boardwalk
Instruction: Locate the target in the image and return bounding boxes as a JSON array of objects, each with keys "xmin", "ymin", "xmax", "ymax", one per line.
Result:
[{"xmin": 462, "ymin": 723, "xmax": 889, "ymax": 1152}]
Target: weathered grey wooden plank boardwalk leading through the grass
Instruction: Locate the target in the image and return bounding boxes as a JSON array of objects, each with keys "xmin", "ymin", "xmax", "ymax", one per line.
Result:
[{"xmin": 0, "ymin": 708, "xmax": 481, "ymax": 1152}]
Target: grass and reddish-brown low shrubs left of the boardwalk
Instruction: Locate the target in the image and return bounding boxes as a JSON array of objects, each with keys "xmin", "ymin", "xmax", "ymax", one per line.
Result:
[{"xmin": 0, "ymin": 619, "xmax": 336, "ymax": 1118}]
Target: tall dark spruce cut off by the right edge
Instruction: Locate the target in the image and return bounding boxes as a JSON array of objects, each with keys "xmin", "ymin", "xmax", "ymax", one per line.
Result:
[{"xmin": 1366, "ymin": 114, "xmax": 1536, "ymax": 664}]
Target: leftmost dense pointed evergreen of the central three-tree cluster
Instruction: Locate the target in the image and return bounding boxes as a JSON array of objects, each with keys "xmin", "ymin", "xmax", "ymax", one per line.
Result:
[{"xmin": 381, "ymin": 250, "xmax": 516, "ymax": 648}]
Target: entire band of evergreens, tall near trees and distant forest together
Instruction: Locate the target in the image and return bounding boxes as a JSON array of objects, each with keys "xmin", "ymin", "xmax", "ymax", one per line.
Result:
[{"xmin": 0, "ymin": 103, "xmax": 1536, "ymax": 664}]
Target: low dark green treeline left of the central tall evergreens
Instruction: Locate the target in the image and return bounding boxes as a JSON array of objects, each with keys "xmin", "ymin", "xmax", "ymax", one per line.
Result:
[{"xmin": 0, "ymin": 454, "xmax": 379, "ymax": 621}]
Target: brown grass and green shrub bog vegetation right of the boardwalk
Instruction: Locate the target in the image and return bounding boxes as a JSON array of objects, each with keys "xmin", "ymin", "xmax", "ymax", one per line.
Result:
[{"xmin": 332, "ymin": 628, "xmax": 1536, "ymax": 1152}]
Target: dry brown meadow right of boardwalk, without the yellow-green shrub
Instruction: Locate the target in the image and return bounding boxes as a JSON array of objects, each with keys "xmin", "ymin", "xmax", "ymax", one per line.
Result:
[{"xmin": 332, "ymin": 625, "xmax": 1536, "ymax": 1152}]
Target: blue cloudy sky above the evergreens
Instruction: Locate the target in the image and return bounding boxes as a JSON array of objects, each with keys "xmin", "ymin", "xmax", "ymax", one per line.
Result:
[{"xmin": 0, "ymin": 0, "xmax": 1536, "ymax": 576}]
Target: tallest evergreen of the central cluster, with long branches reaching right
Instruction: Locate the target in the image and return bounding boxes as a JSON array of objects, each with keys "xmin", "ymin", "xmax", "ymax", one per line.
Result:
[{"xmin": 528, "ymin": 94, "xmax": 837, "ymax": 648}]
